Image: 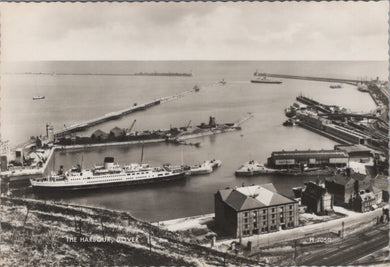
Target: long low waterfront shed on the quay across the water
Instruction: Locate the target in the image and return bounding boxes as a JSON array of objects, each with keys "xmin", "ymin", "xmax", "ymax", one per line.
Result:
[{"xmin": 268, "ymin": 150, "xmax": 348, "ymax": 169}]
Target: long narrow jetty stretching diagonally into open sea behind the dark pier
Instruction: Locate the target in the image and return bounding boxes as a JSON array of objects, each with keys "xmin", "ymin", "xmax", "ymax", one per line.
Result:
[{"xmin": 54, "ymin": 89, "xmax": 195, "ymax": 138}]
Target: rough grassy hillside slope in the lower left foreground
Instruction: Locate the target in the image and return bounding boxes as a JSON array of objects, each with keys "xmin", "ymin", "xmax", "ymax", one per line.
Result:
[{"xmin": 0, "ymin": 198, "xmax": 257, "ymax": 266}]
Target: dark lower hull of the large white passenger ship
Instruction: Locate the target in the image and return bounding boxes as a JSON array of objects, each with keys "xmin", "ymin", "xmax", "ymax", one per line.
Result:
[{"xmin": 32, "ymin": 172, "xmax": 185, "ymax": 191}]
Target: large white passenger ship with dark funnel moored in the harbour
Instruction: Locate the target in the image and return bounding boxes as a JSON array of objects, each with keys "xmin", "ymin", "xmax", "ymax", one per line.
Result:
[{"xmin": 30, "ymin": 157, "xmax": 185, "ymax": 190}]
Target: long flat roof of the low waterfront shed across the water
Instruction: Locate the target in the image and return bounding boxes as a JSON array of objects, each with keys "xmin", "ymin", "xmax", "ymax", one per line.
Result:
[{"xmin": 272, "ymin": 150, "xmax": 348, "ymax": 159}]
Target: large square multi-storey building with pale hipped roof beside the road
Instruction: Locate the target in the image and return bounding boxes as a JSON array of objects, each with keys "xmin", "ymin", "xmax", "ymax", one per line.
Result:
[{"xmin": 214, "ymin": 184, "xmax": 299, "ymax": 237}]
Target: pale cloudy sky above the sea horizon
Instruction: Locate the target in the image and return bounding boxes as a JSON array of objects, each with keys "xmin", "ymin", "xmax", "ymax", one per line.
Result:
[{"xmin": 0, "ymin": 1, "xmax": 389, "ymax": 61}]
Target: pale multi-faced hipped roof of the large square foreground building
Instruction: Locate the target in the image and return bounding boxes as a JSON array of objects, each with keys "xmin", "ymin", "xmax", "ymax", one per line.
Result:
[{"xmin": 217, "ymin": 184, "xmax": 295, "ymax": 211}]
